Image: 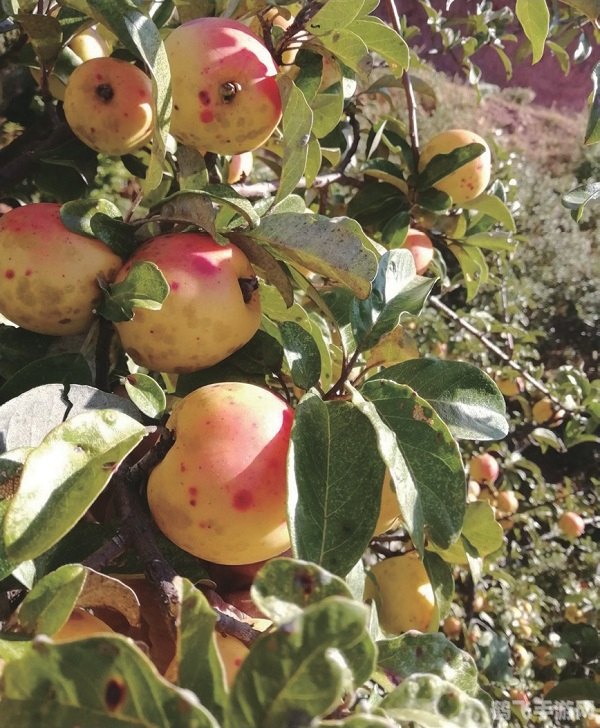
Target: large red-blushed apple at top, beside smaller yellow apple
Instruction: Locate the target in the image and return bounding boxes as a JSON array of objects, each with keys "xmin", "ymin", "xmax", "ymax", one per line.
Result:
[{"xmin": 165, "ymin": 18, "xmax": 281, "ymax": 154}]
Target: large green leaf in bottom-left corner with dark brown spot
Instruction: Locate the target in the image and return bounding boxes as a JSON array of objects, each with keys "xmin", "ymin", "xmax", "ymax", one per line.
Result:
[{"xmin": 1, "ymin": 635, "xmax": 218, "ymax": 728}]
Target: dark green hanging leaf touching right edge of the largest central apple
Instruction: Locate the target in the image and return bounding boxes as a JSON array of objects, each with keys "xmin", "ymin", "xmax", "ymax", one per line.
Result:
[{"xmin": 288, "ymin": 394, "xmax": 384, "ymax": 576}]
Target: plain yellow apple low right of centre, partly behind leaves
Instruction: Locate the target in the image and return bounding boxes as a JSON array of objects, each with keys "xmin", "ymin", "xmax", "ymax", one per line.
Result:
[{"xmin": 364, "ymin": 551, "xmax": 439, "ymax": 634}]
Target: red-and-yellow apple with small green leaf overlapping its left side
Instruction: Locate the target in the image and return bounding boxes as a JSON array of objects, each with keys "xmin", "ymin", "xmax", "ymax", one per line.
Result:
[{"xmin": 116, "ymin": 233, "xmax": 262, "ymax": 372}]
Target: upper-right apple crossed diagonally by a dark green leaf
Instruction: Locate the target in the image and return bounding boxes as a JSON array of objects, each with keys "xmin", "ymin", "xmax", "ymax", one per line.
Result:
[{"xmin": 419, "ymin": 129, "xmax": 492, "ymax": 205}]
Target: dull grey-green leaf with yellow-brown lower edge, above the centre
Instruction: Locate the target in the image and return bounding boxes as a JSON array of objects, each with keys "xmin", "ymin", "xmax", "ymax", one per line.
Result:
[{"xmin": 247, "ymin": 212, "xmax": 377, "ymax": 298}]
